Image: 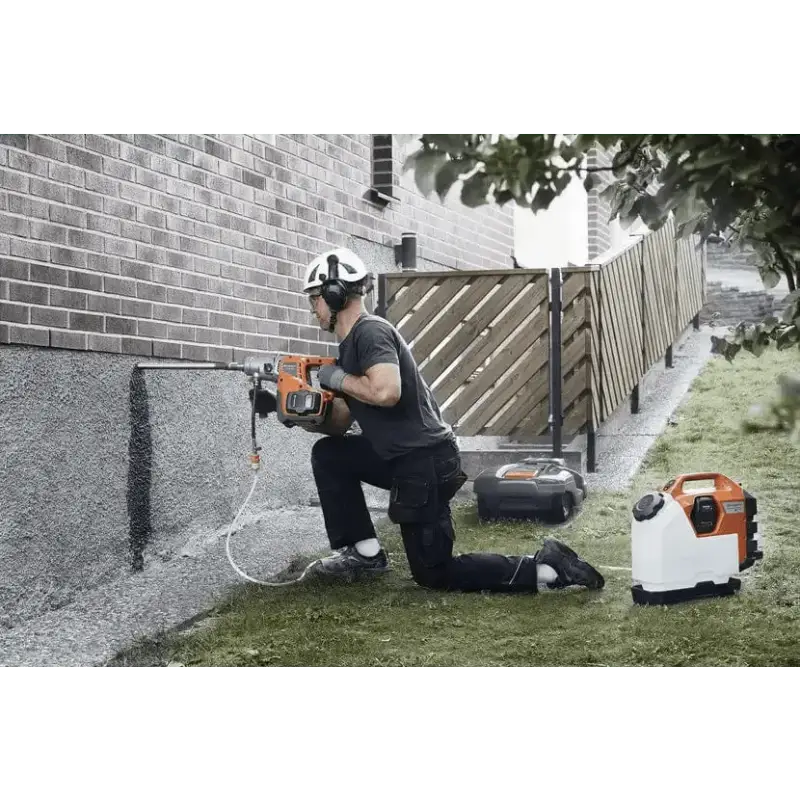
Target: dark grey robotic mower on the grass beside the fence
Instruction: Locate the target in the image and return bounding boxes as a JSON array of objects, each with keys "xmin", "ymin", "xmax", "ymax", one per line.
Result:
[{"xmin": 473, "ymin": 458, "xmax": 586, "ymax": 522}]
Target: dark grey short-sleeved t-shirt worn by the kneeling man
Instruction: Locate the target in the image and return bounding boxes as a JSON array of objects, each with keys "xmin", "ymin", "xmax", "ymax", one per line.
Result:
[{"xmin": 337, "ymin": 314, "xmax": 454, "ymax": 459}]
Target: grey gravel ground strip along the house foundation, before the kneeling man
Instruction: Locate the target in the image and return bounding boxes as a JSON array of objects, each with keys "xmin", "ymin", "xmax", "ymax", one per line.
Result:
[{"xmin": 0, "ymin": 504, "xmax": 379, "ymax": 669}]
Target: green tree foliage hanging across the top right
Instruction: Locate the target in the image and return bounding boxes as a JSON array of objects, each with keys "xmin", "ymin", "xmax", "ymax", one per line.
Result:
[{"xmin": 406, "ymin": 128, "xmax": 800, "ymax": 360}]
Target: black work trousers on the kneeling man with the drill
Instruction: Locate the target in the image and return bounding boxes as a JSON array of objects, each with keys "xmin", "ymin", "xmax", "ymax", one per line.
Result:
[{"xmin": 311, "ymin": 436, "xmax": 537, "ymax": 592}]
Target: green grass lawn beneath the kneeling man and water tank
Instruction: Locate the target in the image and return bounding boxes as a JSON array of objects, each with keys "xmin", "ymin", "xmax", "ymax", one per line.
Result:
[{"xmin": 117, "ymin": 352, "xmax": 800, "ymax": 667}]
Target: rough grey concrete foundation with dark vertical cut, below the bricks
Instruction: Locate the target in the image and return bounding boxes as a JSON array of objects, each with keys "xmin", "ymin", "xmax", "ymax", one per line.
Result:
[{"xmin": 0, "ymin": 346, "xmax": 388, "ymax": 636}]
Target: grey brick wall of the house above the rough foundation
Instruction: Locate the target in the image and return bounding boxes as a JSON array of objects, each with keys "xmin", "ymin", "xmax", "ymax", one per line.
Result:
[{"xmin": 0, "ymin": 128, "xmax": 514, "ymax": 360}]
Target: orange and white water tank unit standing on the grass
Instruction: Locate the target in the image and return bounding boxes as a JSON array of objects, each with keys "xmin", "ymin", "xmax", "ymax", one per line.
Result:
[{"xmin": 631, "ymin": 472, "xmax": 763, "ymax": 605}]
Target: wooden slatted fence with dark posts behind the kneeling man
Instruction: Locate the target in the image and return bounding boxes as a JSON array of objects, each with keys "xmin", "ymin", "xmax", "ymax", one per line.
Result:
[{"xmin": 376, "ymin": 216, "xmax": 705, "ymax": 471}]
